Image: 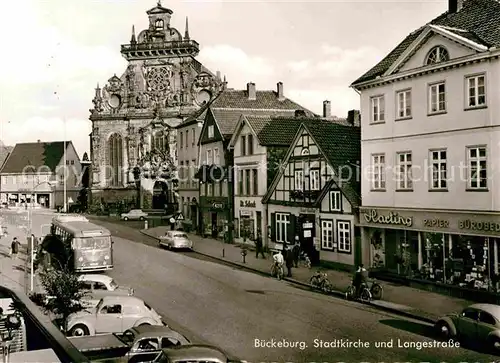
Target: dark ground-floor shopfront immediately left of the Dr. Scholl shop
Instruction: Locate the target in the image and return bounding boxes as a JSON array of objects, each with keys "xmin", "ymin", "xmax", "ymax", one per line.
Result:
[{"xmin": 200, "ymin": 197, "xmax": 229, "ymax": 238}]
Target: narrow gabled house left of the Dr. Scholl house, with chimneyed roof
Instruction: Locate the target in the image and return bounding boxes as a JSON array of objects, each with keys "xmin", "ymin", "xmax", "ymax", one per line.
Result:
[{"xmin": 196, "ymin": 82, "xmax": 314, "ymax": 240}]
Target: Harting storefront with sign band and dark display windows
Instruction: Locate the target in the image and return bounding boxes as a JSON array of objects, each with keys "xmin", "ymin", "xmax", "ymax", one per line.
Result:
[{"xmin": 360, "ymin": 207, "xmax": 500, "ymax": 291}]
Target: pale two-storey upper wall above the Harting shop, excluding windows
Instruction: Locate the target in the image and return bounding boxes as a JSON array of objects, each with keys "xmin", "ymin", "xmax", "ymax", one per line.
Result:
[{"xmin": 361, "ymin": 55, "xmax": 500, "ymax": 211}]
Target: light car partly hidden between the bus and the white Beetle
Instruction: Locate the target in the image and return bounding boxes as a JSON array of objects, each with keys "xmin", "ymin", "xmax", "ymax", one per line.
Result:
[{"xmin": 79, "ymin": 274, "xmax": 134, "ymax": 306}]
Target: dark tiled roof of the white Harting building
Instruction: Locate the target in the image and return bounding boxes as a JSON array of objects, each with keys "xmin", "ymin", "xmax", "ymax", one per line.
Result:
[{"xmin": 351, "ymin": 0, "xmax": 500, "ymax": 86}]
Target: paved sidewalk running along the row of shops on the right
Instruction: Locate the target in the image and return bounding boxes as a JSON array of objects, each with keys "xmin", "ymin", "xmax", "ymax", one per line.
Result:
[{"xmin": 141, "ymin": 227, "xmax": 473, "ymax": 322}]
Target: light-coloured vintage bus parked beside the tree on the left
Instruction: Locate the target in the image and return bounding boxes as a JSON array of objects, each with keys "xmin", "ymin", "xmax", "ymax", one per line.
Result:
[{"xmin": 51, "ymin": 215, "xmax": 113, "ymax": 272}]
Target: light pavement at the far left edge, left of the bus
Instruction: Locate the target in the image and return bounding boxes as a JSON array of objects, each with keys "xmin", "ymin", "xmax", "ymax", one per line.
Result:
[{"xmin": 0, "ymin": 213, "xmax": 41, "ymax": 293}]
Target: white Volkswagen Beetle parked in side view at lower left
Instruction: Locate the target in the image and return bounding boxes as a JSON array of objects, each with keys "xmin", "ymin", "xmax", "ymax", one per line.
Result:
[{"xmin": 68, "ymin": 296, "xmax": 164, "ymax": 336}]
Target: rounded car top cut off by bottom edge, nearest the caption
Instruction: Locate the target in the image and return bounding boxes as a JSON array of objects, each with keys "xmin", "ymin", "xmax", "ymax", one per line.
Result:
[{"xmin": 153, "ymin": 344, "xmax": 238, "ymax": 363}]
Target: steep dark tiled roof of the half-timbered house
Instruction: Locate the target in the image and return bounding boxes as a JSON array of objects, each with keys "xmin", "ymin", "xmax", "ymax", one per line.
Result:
[{"xmin": 262, "ymin": 120, "xmax": 361, "ymax": 207}]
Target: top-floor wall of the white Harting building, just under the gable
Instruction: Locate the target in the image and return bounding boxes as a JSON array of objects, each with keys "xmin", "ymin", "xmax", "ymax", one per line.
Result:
[{"xmin": 361, "ymin": 60, "xmax": 500, "ymax": 141}]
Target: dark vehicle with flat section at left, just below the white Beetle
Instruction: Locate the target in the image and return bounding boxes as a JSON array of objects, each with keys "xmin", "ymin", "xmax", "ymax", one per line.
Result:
[{"xmin": 69, "ymin": 325, "xmax": 190, "ymax": 363}]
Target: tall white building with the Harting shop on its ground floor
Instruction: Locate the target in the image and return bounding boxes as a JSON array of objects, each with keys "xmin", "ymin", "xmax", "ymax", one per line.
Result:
[{"xmin": 352, "ymin": 0, "xmax": 500, "ymax": 290}]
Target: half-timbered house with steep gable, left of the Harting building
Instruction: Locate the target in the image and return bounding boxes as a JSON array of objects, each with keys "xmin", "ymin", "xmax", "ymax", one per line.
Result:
[{"xmin": 263, "ymin": 120, "xmax": 361, "ymax": 266}]
